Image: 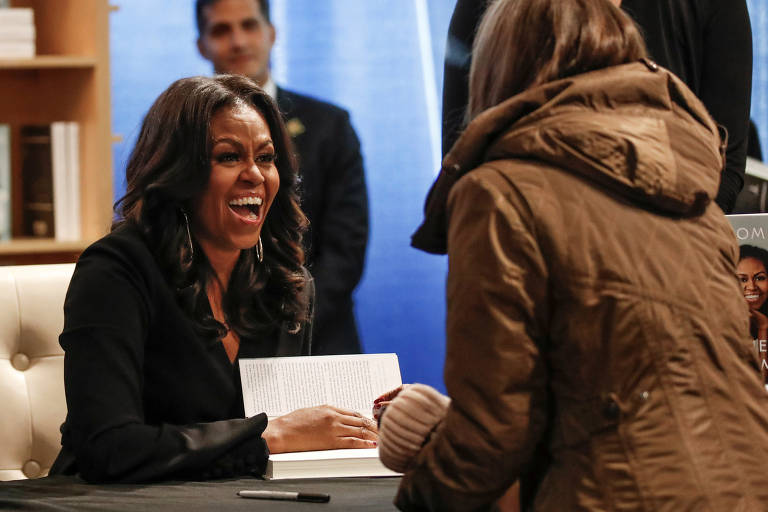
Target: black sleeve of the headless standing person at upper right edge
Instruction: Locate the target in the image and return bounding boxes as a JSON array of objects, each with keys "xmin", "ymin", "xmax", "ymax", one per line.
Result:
[{"xmin": 700, "ymin": 0, "xmax": 752, "ymax": 213}]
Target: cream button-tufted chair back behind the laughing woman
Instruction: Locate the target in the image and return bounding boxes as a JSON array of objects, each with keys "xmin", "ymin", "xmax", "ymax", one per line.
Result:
[{"xmin": 0, "ymin": 264, "xmax": 75, "ymax": 480}]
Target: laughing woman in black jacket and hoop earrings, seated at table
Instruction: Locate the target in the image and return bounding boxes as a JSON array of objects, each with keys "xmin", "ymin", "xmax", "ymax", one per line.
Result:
[{"xmin": 51, "ymin": 75, "xmax": 376, "ymax": 482}]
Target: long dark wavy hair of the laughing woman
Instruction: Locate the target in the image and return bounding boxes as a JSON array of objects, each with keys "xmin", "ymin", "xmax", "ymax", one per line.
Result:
[{"xmin": 113, "ymin": 75, "xmax": 308, "ymax": 338}]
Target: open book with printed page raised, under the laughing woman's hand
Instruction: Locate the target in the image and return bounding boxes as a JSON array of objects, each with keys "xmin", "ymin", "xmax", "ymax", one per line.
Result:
[{"xmin": 240, "ymin": 354, "xmax": 402, "ymax": 479}]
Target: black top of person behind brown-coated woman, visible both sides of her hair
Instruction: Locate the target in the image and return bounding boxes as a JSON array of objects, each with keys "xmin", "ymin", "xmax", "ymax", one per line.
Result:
[{"xmin": 443, "ymin": 0, "xmax": 752, "ymax": 213}]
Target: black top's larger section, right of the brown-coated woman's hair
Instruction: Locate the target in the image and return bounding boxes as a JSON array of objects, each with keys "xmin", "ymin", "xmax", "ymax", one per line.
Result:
[{"xmin": 621, "ymin": 0, "xmax": 752, "ymax": 213}]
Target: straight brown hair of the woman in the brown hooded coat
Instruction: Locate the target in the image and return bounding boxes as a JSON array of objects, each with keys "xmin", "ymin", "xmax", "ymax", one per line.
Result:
[{"xmin": 467, "ymin": 0, "xmax": 646, "ymax": 120}]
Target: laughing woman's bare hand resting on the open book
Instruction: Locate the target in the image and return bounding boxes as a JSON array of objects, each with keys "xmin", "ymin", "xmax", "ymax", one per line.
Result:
[{"xmin": 262, "ymin": 405, "xmax": 379, "ymax": 453}]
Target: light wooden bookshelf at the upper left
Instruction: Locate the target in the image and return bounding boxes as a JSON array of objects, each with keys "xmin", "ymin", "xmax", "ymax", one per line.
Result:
[{"xmin": 0, "ymin": 0, "xmax": 113, "ymax": 265}]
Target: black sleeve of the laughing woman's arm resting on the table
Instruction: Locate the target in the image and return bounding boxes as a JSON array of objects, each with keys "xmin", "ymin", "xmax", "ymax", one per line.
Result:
[{"xmin": 60, "ymin": 251, "xmax": 268, "ymax": 482}]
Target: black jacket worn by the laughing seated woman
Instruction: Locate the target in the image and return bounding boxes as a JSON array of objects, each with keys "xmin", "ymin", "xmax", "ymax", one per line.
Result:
[{"xmin": 51, "ymin": 222, "xmax": 311, "ymax": 482}]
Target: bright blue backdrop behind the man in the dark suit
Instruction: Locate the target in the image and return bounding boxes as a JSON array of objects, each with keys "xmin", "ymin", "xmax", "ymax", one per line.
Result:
[{"xmin": 110, "ymin": 0, "xmax": 455, "ymax": 389}]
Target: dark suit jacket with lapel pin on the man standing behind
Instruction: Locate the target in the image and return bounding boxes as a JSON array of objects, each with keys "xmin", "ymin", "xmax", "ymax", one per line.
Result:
[{"xmin": 277, "ymin": 88, "xmax": 368, "ymax": 354}]
